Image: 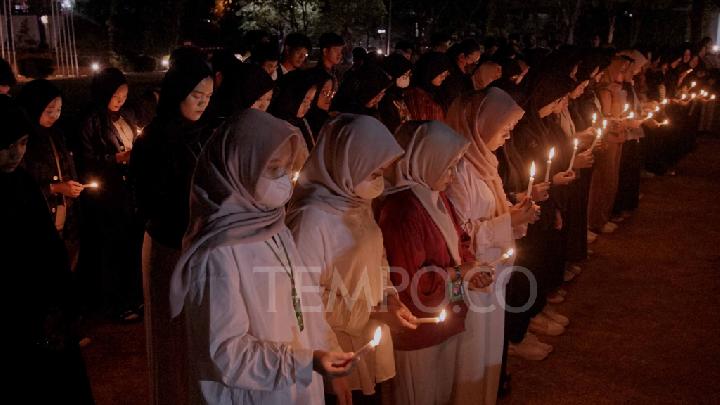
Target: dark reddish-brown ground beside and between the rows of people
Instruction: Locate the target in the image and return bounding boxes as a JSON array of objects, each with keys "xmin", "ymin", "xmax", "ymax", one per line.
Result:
[{"xmin": 85, "ymin": 140, "xmax": 720, "ymax": 405}]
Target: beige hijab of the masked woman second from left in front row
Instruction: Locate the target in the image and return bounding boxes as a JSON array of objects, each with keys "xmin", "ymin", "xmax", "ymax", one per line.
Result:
[{"xmin": 288, "ymin": 114, "xmax": 403, "ymax": 215}]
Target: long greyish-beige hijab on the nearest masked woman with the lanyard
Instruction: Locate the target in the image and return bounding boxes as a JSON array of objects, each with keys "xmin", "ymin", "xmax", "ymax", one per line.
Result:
[{"xmin": 170, "ymin": 109, "xmax": 304, "ymax": 317}]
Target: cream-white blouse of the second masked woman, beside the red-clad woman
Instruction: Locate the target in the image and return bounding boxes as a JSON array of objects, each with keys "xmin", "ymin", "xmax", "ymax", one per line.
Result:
[{"xmin": 290, "ymin": 206, "xmax": 395, "ymax": 395}]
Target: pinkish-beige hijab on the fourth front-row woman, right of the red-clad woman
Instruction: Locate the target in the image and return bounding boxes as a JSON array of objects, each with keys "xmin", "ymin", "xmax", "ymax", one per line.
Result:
[{"xmin": 446, "ymin": 87, "xmax": 525, "ymax": 215}]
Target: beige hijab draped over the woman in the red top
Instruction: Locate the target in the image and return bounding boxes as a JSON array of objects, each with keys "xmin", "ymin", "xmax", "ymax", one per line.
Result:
[{"xmin": 388, "ymin": 121, "xmax": 470, "ymax": 264}]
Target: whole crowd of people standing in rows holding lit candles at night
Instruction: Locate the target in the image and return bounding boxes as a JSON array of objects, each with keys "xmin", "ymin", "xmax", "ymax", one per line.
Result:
[{"xmin": 0, "ymin": 33, "xmax": 718, "ymax": 405}]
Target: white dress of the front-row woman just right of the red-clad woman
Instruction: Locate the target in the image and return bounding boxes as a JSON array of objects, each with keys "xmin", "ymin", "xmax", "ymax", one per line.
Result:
[{"xmin": 447, "ymin": 162, "xmax": 522, "ymax": 405}]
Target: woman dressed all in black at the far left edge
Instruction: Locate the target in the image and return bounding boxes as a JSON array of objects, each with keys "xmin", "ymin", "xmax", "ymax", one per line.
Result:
[{"xmin": 0, "ymin": 96, "xmax": 94, "ymax": 405}]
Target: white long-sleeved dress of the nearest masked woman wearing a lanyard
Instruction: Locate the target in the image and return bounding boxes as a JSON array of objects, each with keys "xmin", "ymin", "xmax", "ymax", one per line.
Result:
[{"xmin": 184, "ymin": 227, "xmax": 328, "ymax": 405}]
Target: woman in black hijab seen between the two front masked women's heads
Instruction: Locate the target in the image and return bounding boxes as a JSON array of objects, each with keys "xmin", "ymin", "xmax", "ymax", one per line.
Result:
[{"xmin": 268, "ymin": 70, "xmax": 318, "ymax": 150}]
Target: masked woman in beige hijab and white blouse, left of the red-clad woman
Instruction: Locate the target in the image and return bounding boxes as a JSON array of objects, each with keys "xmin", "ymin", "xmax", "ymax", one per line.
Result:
[{"xmin": 288, "ymin": 114, "xmax": 416, "ymax": 404}]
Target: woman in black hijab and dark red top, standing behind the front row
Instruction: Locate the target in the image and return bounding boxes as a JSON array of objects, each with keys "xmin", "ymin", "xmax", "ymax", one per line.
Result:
[{"xmin": 405, "ymin": 52, "xmax": 450, "ymax": 121}]
